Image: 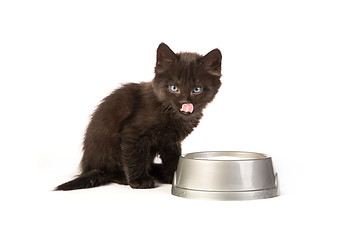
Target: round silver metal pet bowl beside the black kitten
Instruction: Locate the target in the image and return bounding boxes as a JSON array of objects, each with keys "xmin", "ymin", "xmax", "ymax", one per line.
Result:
[{"xmin": 171, "ymin": 152, "xmax": 278, "ymax": 200}]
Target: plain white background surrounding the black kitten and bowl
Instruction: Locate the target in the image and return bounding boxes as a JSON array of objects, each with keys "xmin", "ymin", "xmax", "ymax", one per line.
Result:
[{"xmin": 0, "ymin": 0, "xmax": 360, "ymax": 239}]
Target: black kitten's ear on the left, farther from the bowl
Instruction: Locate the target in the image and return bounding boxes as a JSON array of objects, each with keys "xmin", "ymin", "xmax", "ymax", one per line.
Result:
[{"xmin": 155, "ymin": 43, "xmax": 177, "ymax": 73}]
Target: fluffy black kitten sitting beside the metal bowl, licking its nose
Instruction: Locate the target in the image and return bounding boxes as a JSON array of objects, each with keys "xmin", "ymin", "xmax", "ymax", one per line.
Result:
[{"xmin": 56, "ymin": 43, "xmax": 221, "ymax": 190}]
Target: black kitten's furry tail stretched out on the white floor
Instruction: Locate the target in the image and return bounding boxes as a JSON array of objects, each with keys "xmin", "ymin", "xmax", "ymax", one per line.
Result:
[{"xmin": 54, "ymin": 170, "xmax": 127, "ymax": 191}]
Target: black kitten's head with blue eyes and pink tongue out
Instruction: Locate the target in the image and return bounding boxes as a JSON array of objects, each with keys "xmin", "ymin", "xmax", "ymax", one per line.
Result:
[{"xmin": 152, "ymin": 43, "xmax": 221, "ymax": 117}]
